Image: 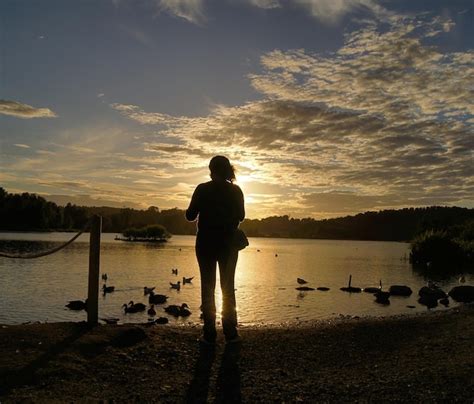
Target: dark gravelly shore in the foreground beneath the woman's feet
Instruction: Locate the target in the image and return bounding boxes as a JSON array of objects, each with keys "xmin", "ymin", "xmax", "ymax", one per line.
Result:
[{"xmin": 0, "ymin": 305, "xmax": 474, "ymax": 403}]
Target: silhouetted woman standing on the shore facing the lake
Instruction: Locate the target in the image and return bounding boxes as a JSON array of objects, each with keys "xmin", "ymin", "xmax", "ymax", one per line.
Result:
[{"xmin": 186, "ymin": 156, "xmax": 245, "ymax": 343}]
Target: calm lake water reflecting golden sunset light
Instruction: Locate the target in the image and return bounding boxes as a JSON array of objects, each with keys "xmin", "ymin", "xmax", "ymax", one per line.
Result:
[{"xmin": 0, "ymin": 233, "xmax": 466, "ymax": 325}]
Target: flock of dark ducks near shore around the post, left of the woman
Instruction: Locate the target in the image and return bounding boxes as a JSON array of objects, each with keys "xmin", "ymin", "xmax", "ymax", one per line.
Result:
[{"xmin": 66, "ymin": 268, "xmax": 194, "ymax": 324}]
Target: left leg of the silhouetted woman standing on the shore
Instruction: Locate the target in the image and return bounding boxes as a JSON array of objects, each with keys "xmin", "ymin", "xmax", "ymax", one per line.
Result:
[{"xmin": 196, "ymin": 245, "xmax": 217, "ymax": 342}]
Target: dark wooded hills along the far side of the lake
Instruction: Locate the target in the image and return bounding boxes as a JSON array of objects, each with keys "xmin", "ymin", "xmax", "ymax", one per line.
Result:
[{"xmin": 0, "ymin": 188, "xmax": 474, "ymax": 241}]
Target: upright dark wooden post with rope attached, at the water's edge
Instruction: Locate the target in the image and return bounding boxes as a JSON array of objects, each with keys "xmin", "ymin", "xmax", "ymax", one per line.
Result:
[{"xmin": 87, "ymin": 215, "xmax": 102, "ymax": 325}]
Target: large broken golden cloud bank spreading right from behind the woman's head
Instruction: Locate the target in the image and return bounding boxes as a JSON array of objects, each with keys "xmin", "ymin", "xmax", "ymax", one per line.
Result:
[{"xmin": 114, "ymin": 17, "xmax": 474, "ymax": 216}]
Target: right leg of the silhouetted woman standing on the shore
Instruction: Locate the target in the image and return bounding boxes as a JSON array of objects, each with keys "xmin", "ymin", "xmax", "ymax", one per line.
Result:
[{"xmin": 218, "ymin": 249, "xmax": 239, "ymax": 339}]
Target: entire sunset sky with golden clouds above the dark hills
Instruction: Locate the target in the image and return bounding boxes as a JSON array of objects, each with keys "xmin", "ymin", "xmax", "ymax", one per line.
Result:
[{"xmin": 0, "ymin": 0, "xmax": 474, "ymax": 218}]
